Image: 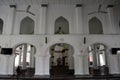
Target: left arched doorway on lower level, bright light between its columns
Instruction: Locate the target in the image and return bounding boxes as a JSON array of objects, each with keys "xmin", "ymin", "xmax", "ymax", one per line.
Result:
[{"xmin": 14, "ymin": 43, "xmax": 36, "ymax": 76}]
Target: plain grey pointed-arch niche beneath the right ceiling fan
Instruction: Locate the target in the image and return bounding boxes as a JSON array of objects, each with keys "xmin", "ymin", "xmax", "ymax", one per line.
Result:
[{"xmin": 89, "ymin": 17, "xmax": 103, "ymax": 34}]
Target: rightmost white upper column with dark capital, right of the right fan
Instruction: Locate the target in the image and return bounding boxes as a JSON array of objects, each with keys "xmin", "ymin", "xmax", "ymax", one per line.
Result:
[{"xmin": 107, "ymin": 5, "xmax": 116, "ymax": 34}]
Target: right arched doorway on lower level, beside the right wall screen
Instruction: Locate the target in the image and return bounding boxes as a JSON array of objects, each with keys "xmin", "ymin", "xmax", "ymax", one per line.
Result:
[{"xmin": 88, "ymin": 43, "xmax": 109, "ymax": 75}]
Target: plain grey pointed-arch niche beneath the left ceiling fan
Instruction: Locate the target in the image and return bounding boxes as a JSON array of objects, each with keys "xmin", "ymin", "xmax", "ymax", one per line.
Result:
[{"xmin": 20, "ymin": 17, "xmax": 34, "ymax": 34}]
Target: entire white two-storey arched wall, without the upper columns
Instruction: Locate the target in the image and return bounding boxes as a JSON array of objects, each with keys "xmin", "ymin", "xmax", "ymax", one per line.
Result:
[{"xmin": 0, "ymin": 4, "xmax": 120, "ymax": 75}]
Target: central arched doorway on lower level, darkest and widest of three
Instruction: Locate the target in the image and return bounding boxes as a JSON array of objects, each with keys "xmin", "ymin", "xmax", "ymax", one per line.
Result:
[{"xmin": 50, "ymin": 43, "xmax": 74, "ymax": 75}]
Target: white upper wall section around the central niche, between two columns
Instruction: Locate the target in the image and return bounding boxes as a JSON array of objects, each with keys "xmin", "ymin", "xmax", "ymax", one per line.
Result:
[{"xmin": 47, "ymin": 4, "xmax": 76, "ymax": 34}]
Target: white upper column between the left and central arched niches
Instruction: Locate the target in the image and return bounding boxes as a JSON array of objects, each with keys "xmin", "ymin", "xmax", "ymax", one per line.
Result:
[{"xmin": 38, "ymin": 4, "xmax": 47, "ymax": 34}]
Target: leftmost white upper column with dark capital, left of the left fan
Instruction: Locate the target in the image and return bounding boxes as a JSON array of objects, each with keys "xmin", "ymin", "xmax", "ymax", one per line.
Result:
[{"xmin": 4, "ymin": 5, "xmax": 16, "ymax": 35}]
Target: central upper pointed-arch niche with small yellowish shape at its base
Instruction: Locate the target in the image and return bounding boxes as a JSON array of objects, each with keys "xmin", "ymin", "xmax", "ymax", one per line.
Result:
[{"xmin": 55, "ymin": 16, "xmax": 69, "ymax": 34}]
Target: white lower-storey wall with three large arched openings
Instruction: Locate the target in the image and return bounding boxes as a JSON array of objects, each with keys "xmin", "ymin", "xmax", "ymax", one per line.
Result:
[{"xmin": 0, "ymin": 35, "xmax": 120, "ymax": 75}]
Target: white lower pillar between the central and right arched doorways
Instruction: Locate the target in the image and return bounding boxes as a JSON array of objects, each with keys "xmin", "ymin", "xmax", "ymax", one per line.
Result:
[{"xmin": 74, "ymin": 54, "xmax": 84, "ymax": 75}]
